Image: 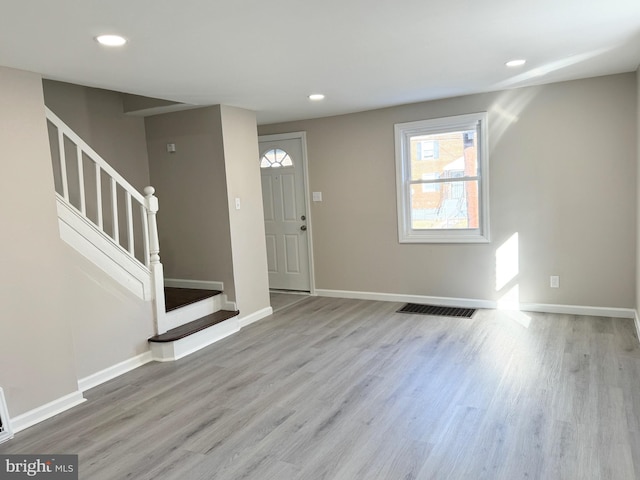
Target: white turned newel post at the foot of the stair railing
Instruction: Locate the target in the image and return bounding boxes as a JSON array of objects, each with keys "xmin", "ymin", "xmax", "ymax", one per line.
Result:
[{"xmin": 144, "ymin": 187, "xmax": 167, "ymax": 335}]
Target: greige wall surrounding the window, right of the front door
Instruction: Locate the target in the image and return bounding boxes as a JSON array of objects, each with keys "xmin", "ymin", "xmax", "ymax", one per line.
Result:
[{"xmin": 259, "ymin": 73, "xmax": 638, "ymax": 308}]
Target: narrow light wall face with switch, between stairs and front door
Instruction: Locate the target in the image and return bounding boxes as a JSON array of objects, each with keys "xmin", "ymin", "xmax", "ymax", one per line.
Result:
[{"xmin": 220, "ymin": 105, "xmax": 270, "ymax": 315}]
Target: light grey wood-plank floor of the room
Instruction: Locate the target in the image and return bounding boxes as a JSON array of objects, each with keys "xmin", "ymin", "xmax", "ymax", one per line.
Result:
[{"xmin": 0, "ymin": 297, "xmax": 640, "ymax": 480}]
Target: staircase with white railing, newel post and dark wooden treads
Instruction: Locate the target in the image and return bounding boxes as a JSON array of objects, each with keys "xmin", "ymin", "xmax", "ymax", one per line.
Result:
[{"xmin": 46, "ymin": 108, "xmax": 240, "ymax": 361}]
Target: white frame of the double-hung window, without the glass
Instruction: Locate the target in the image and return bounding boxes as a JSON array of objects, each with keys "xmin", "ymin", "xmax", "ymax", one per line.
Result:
[{"xmin": 394, "ymin": 112, "xmax": 490, "ymax": 243}]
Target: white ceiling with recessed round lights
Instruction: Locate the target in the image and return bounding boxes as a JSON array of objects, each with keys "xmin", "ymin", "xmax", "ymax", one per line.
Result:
[{"xmin": 0, "ymin": 0, "xmax": 640, "ymax": 124}]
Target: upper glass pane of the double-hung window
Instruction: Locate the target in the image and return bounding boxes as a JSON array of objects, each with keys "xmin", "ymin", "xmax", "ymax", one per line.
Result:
[{"xmin": 409, "ymin": 130, "xmax": 478, "ymax": 180}]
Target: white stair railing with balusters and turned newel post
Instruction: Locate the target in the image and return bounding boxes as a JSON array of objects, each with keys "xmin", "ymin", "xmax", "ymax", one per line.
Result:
[{"xmin": 45, "ymin": 107, "xmax": 166, "ymax": 334}]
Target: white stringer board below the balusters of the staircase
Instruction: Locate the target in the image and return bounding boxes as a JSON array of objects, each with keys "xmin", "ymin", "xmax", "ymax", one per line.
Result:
[{"xmin": 56, "ymin": 194, "xmax": 151, "ymax": 300}]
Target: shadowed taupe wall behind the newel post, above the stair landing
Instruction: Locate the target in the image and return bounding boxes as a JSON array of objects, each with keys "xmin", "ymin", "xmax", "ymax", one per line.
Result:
[{"xmin": 146, "ymin": 106, "xmax": 235, "ymax": 300}]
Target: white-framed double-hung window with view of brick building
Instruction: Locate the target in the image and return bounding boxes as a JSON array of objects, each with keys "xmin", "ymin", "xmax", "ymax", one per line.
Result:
[{"xmin": 395, "ymin": 113, "xmax": 489, "ymax": 243}]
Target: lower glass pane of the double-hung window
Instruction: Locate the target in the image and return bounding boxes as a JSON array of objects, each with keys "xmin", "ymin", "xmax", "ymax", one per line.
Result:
[{"xmin": 411, "ymin": 180, "xmax": 480, "ymax": 230}]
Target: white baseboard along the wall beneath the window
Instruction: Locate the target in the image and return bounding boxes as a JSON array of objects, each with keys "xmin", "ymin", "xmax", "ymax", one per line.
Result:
[{"xmin": 315, "ymin": 289, "xmax": 640, "ymax": 318}]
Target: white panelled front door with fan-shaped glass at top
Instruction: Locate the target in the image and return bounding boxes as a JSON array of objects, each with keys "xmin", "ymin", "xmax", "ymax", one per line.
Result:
[{"xmin": 259, "ymin": 134, "xmax": 311, "ymax": 292}]
